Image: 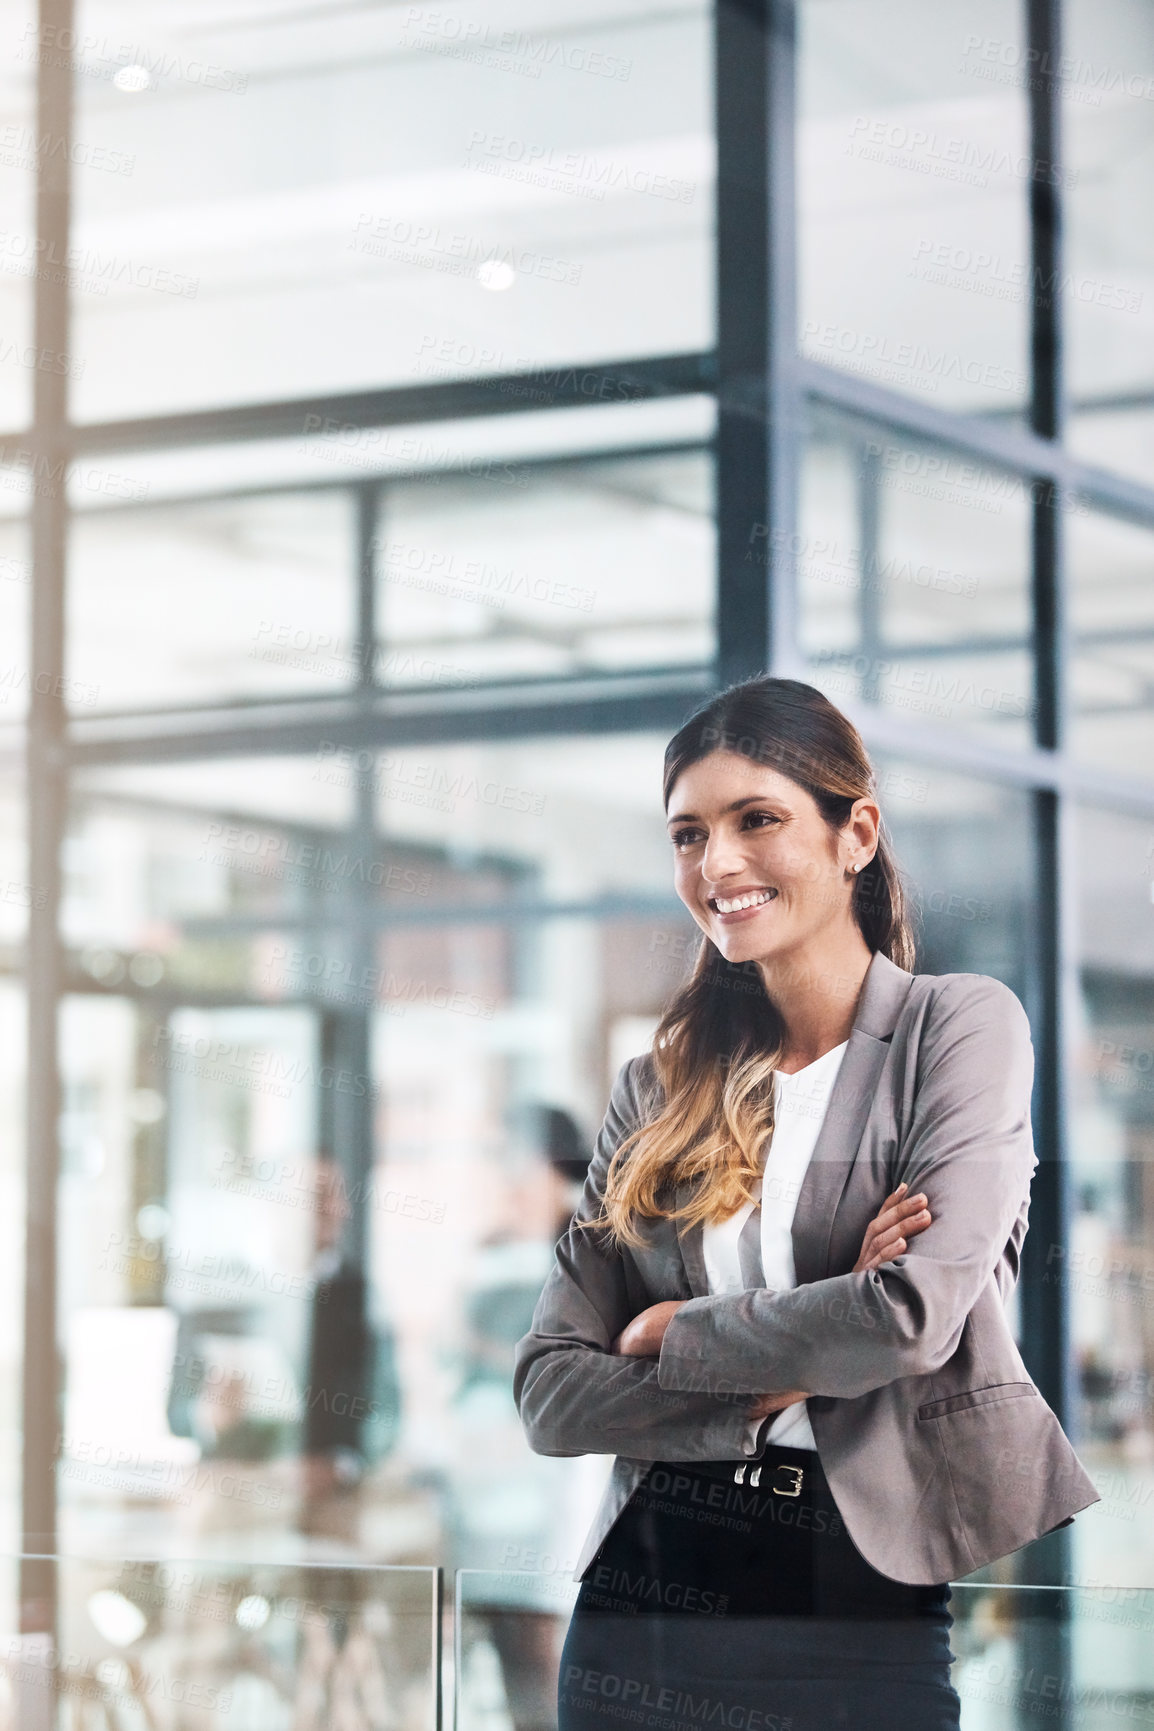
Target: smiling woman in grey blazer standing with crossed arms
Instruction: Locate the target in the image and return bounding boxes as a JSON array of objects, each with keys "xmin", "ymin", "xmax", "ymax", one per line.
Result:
[{"xmin": 516, "ymin": 679, "xmax": 1097, "ymax": 1731}]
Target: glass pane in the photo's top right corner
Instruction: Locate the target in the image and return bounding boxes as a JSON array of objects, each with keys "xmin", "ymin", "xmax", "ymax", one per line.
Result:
[{"xmin": 1062, "ymin": 0, "xmax": 1154, "ymax": 483}]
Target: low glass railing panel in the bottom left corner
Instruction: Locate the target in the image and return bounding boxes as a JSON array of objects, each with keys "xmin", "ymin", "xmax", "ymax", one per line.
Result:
[{"xmin": 0, "ymin": 1556, "xmax": 441, "ymax": 1731}]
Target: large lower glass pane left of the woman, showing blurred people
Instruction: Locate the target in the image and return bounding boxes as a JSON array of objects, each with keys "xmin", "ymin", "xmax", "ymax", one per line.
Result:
[{"xmin": 61, "ymin": 734, "xmax": 690, "ymax": 1567}]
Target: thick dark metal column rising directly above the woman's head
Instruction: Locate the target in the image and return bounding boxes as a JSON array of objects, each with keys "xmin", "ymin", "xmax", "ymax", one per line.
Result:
[{"xmin": 715, "ymin": 0, "xmax": 799, "ymax": 684}]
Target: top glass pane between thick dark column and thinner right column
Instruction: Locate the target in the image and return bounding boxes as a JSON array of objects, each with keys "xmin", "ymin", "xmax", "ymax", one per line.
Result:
[{"xmin": 798, "ymin": 0, "xmax": 1031, "ymax": 415}]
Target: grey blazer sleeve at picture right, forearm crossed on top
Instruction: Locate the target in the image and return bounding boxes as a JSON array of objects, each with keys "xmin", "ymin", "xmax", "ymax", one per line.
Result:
[{"xmin": 657, "ymin": 975, "xmax": 1036, "ymax": 1399}]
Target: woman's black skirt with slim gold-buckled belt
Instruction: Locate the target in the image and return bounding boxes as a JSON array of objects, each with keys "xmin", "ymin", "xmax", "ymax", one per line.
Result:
[{"xmin": 559, "ymin": 1449, "xmax": 958, "ymax": 1731}]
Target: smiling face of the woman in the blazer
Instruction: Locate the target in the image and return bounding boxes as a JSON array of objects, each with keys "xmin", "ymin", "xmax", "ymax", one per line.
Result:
[{"xmin": 668, "ymin": 751, "xmax": 879, "ymax": 962}]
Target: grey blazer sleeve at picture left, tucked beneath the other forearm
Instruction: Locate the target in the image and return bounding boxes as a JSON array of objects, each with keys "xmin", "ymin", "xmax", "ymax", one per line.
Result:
[{"xmin": 514, "ymin": 1058, "xmax": 768, "ymax": 1461}]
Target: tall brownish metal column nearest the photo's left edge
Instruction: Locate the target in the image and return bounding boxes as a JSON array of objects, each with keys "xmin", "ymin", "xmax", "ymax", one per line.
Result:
[{"xmin": 21, "ymin": 0, "xmax": 73, "ymax": 1634}]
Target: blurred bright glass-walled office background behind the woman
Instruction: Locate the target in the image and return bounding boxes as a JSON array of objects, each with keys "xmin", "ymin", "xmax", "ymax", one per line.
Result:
[{"xmin": 0, "ymin": 0, "xmax": 1154, "ymax": 1731}]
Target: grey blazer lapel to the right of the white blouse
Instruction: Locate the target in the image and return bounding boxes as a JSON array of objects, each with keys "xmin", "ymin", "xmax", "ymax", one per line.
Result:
[{"xmin": 791, "ymin": 950, "xmax": 914, "ymax": 1286}]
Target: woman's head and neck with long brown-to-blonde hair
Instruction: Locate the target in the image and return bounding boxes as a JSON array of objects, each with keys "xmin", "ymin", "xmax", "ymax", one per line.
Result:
[{"xmin": 604, "ymin": 679, "xmax": 914, "ymax": 1241}]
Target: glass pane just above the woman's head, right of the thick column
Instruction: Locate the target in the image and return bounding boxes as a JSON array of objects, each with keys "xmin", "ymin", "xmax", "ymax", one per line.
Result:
[{"xmin": 799, "ymin": 415, "xmax": 1033, "ymax": 744}]
